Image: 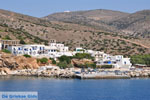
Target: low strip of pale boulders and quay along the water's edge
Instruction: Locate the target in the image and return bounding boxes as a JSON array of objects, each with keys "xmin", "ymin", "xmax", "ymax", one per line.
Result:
[{"xmin": 0, "ymin": 66, "xmax": 150, "ymax": 79}]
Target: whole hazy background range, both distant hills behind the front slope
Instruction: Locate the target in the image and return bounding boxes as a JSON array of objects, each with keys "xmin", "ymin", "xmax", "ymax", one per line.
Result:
[{"xmin": 44, "ymin": 10, "xmax": 150, "ymax": 38}]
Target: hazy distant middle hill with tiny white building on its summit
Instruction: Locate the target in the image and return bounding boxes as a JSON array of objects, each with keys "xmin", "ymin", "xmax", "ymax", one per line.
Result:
[{"xmin": 44, "ymin": 9, "xmax": 129, "ymax": 32}]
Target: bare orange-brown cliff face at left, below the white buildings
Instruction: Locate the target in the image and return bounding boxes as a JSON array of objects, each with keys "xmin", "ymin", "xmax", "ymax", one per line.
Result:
[{"xmin": 0, "ymin": 52, "xmax": 39, "ymax": 70}]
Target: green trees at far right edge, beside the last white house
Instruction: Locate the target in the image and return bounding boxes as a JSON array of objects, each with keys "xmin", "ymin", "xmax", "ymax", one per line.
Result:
[{"xmin": 131, "ymin": 54, "xmax": 150, "ymax": 66}]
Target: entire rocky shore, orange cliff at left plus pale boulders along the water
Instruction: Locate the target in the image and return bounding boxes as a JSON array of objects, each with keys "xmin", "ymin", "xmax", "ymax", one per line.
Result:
[{"xmin": 0, "ymin": 52, "xmax": 150, "ymax": 79}]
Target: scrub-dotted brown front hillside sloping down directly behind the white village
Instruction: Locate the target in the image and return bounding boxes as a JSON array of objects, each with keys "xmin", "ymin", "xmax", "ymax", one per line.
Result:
[{"xmin": 0, "ymin": 10, "xmax": 150, "ymax": 55}]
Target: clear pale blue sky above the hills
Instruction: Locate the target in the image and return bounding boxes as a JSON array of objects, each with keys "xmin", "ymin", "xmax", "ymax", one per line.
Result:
[{"xmin": 0, "ymin": 0, "xmax": 150, "ymax": 17}]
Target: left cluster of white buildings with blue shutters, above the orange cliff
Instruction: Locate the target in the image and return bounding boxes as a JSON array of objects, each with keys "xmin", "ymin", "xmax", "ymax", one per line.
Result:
[{"xmin": 8, "ymin": 43, "xmax": 73, "ymax": 58}]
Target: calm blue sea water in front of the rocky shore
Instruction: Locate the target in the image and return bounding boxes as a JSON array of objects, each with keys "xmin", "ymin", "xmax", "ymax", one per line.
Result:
[{"xmin": 0, "ymin": 77, "xmax": 150, "ymax": 100}]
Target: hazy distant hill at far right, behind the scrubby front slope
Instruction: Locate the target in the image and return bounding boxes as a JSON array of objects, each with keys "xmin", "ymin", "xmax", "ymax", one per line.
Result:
[{"xmin": 109, "ymin": 10, "xmax": 150, "ymax": 38}]
